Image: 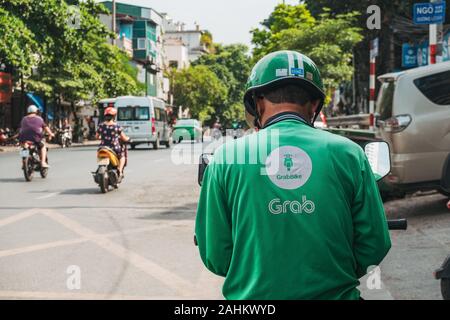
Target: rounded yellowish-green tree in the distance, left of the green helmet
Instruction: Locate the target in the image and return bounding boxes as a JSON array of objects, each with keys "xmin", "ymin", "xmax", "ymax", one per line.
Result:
[{"xmin": 173, "ymin": 65, "xmax": 227, "ymax": 121}]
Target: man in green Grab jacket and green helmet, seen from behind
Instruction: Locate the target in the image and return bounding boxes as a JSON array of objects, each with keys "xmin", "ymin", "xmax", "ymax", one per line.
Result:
[{"xmin": 195, "ymin": 51, "xmax": 391, "ymax": 300}]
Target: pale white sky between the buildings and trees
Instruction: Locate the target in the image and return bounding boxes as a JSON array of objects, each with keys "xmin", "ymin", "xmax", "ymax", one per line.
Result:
[{"xmin": 97, "ymin": 0, "xmax": 299, "ymax": 46}]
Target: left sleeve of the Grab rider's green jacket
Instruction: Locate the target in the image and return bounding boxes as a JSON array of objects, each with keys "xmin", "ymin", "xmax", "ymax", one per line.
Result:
[{"xmin": 195, "ymin": 164, "xmax": 233, "ymax": 277}]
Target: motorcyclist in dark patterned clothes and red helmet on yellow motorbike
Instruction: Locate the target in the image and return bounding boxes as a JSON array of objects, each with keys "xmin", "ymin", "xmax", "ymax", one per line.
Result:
[{"xmin": 96, "ymin": 107, "xmax": 130, "ymax": 179}]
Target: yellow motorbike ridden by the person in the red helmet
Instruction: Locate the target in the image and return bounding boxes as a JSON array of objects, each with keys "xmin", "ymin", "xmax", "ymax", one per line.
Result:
[{"xmin": 92, "ymin": 142, "xmax": 131, "ymax": 193}]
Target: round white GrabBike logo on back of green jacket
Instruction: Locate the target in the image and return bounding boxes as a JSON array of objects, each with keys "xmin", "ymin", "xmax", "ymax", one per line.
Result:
[{"xmin": 265, "ymin": 146, "xmax": 312, "ymax": 190}]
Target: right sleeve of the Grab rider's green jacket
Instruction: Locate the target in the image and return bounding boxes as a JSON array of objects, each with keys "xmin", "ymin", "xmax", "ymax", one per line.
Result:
[{"xmin": 352, "ymin": 154, "xmax": 391, "ymax": 278}]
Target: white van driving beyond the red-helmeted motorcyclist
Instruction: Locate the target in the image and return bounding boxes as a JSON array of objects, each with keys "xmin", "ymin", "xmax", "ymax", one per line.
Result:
[{"xmin": 115, "ymin": 96, "xmax": 171, "ymax": 149}]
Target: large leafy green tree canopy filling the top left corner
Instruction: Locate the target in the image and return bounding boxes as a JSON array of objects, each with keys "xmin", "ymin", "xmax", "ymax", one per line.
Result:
[{"xmin": 0, "ymin": 0, "xmax": 143, "ymax": 106}]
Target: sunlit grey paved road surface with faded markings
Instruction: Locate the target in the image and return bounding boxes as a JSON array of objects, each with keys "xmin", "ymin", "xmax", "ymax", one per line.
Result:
[{"xmin": 0, "ymin": 143, "xmax": 450, "ymax": 299}]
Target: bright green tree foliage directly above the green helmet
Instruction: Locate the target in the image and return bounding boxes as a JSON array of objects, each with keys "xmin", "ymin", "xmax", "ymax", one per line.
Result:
[{"xmin": 252, "ymin": 4, "xmax": 362, "ymax": 96}]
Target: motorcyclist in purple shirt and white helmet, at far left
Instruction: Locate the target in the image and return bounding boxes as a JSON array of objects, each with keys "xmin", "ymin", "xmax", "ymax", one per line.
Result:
[{"xmin": 19, "ymin": 105, "xmax": 55, "ymax": 168}]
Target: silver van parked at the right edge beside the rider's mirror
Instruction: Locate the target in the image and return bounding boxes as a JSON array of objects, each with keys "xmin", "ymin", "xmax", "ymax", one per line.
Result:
[{"xmin": 375, "ymin": 62, "xmax": 450, "ymax": 195}]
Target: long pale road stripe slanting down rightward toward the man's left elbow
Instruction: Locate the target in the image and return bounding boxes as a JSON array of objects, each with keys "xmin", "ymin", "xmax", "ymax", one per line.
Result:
[{"xmin": 43, "ymin": 210, "xmax": 193, "ymax": 296}]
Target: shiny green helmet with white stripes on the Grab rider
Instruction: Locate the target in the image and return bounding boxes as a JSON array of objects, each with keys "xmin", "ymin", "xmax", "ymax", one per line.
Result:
[{"xmin": 244, "ymin": 50, "xmax": 325, "ymax": 125}]
